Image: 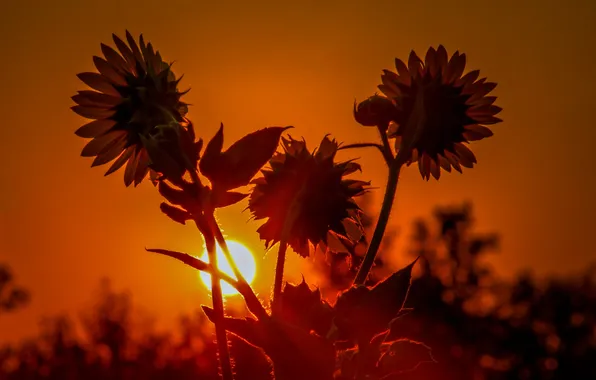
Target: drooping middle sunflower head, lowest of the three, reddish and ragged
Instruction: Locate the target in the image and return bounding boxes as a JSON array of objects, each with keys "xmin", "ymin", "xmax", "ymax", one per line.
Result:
[{"xmin": 248, "ymin": 137, "xmax": 368, "ymax": 257}]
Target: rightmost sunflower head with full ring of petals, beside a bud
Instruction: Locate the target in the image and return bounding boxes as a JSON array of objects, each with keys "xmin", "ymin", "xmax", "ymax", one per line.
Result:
[{"xmin": 366, "ymin": 45, "xmax": 501, "ymax": 180}]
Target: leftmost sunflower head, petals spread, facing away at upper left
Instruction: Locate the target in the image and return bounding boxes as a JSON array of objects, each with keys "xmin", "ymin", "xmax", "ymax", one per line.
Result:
[{"xmin": 72, "ymin": 31, "xmax": 189, "ymax": 186}]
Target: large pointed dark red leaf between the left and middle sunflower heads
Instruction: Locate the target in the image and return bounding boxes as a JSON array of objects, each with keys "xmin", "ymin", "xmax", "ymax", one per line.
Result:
[{"xmin": 199, "ymin": 124, "xmax": 291, "ymax": 190}]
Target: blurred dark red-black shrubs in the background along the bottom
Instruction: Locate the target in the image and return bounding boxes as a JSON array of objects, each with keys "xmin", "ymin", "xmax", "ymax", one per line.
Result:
[{"xmin": 0, "ymin": 204, "xmax": 596, "ymax": 380}]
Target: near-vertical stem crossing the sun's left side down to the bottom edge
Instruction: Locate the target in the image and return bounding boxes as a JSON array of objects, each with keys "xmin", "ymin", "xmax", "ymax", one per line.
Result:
[{"xmin": 195, "ymin": 219, "xmax": 234, "ymax": 380}]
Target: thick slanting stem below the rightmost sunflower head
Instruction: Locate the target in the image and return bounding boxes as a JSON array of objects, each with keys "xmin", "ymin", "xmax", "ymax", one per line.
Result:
[{"xmin": 354, "ymin": 159, "xmax": 402, "ymax": 285}]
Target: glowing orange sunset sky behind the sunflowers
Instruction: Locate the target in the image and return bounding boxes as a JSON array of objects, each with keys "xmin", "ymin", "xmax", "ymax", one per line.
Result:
[{"xmin": 0, "ymin": 0, "xmax": 596, "ymax": 341}]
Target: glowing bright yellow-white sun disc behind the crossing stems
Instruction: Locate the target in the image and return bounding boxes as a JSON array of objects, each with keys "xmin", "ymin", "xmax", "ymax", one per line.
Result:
[{"xmin": 200, "ymin": 240, "xmax": 257, "ymax": 296}]
